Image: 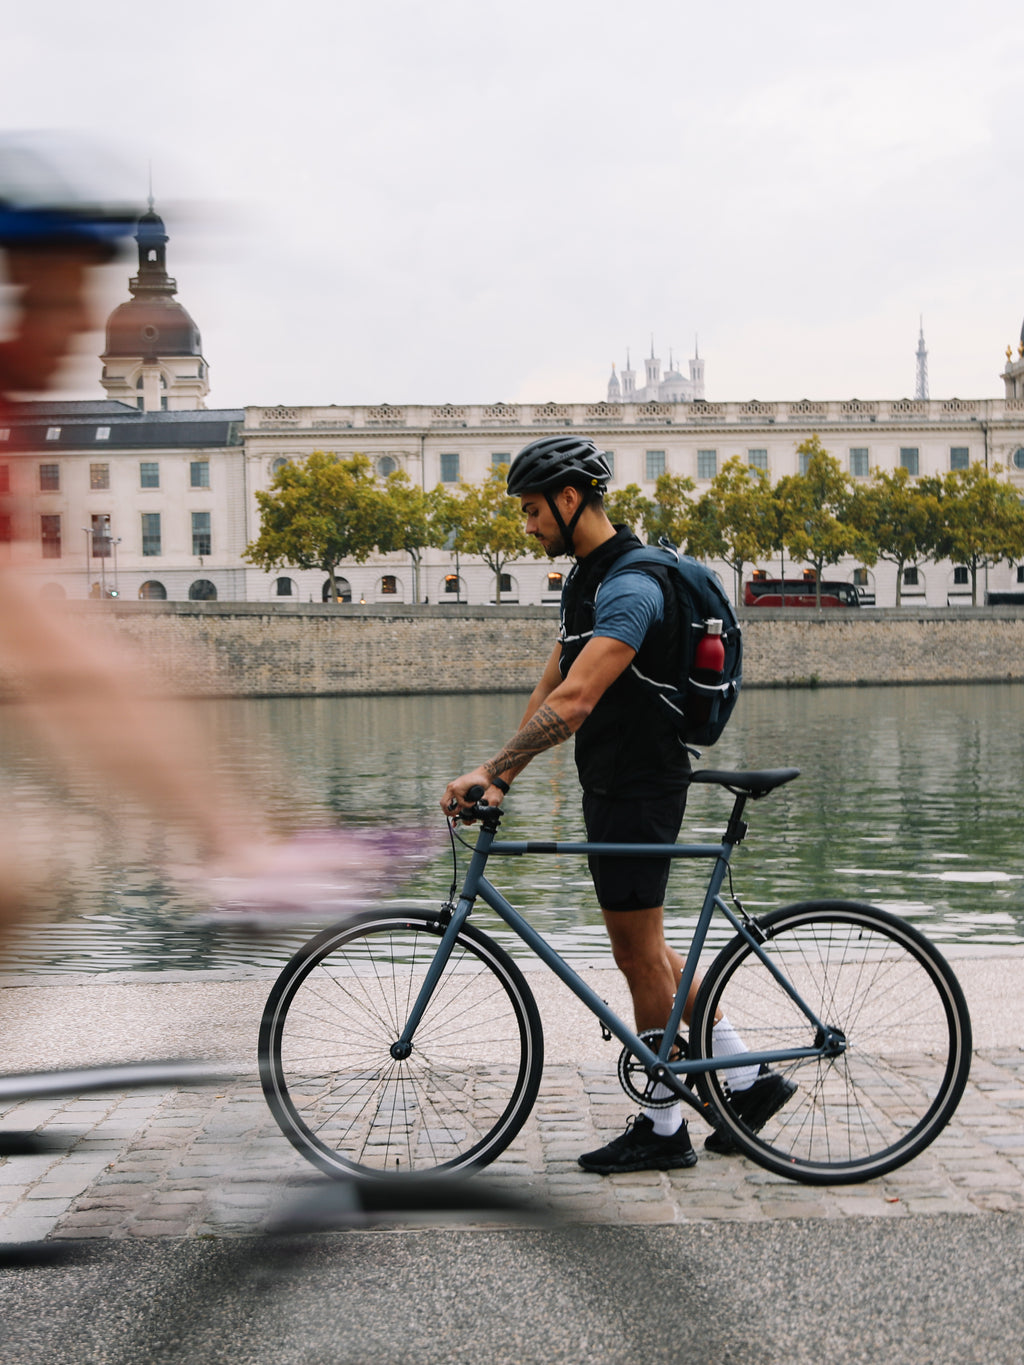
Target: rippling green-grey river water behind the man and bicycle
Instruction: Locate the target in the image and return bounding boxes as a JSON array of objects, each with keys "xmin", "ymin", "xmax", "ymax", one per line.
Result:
[{"xmin": 0, "ymin": 684, "xmax": 1024, "ymax": 972}]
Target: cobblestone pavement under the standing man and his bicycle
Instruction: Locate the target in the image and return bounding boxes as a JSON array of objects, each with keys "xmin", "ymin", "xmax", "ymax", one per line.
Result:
[{"xmin": 0, "ymin": 1047, "xmax": 1024, "ymax": 1241}]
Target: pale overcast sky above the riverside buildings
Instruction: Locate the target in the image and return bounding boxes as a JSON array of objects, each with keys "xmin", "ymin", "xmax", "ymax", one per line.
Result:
[{"xmin": 0, "ymin": 0, "xmax": 1024, "ymax": 407}]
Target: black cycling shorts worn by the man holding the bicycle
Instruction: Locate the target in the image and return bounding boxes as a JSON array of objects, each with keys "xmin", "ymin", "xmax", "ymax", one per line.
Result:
[{"xmin": 583, "ymin": 788, "xmax": 687, "ymax": 910}]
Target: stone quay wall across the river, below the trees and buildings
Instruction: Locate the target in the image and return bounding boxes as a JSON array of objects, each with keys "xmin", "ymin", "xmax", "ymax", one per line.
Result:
[{"xmin": 0, "ymin": 602, "xmax": 1024, "ymax": 696}]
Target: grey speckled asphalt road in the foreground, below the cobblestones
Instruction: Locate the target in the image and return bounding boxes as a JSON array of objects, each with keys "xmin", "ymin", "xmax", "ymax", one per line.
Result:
[{"xmin": 0, "ymin": 1213, "xmax": 1024, "ymax": 1365}]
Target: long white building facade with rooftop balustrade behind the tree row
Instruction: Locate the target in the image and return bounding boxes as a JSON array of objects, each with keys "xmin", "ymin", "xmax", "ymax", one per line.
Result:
[{"xmin": 242, "ymin": 395, "xmax": 1024, "ymax": 606}]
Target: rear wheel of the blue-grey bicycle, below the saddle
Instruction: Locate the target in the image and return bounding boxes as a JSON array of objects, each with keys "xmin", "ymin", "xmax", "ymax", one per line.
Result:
[{"xmin": 689, "ymin": 901, "xmax": 971, "ymax": 1185}]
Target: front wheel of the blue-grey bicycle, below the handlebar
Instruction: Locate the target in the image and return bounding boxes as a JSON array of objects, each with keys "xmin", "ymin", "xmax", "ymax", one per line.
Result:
[{"xmin": 259, "ymin": 910, "xmax": 543, "ymax": 1178}]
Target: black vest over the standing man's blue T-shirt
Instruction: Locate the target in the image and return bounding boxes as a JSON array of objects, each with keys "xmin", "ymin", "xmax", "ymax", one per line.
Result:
[{"xmin": 558, "ymin": 526, "xmax": 689, "ymax": 800}]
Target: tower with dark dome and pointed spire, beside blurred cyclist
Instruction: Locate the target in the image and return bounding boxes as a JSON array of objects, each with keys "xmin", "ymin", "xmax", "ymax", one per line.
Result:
[{"xmin": 100, "ymin": 199, "xmax": 210, "ymax": 412}]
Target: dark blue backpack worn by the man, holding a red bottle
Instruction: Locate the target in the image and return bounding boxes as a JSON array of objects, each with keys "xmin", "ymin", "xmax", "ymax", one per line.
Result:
[{"xmin": 602, "ymin": 536, "xmax": 743, "ymax": 744}]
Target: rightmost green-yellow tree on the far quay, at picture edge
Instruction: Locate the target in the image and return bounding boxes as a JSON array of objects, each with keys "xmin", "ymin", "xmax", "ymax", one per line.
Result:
[{"xmin": 922, "ymin": 463, "xmax": 1024, "ymax": 606}]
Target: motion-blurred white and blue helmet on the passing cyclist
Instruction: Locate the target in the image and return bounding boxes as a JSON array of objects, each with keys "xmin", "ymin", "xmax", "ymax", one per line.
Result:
[{"xmin": 0, "ymin": 132, "xmax": 141, "ymax": 255}]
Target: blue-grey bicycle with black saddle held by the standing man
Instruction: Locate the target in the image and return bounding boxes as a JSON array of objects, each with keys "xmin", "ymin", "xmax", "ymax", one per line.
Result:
[{"xmin": 259, "ymin": 768, "xmax": 971, "ymax": 1185}]
